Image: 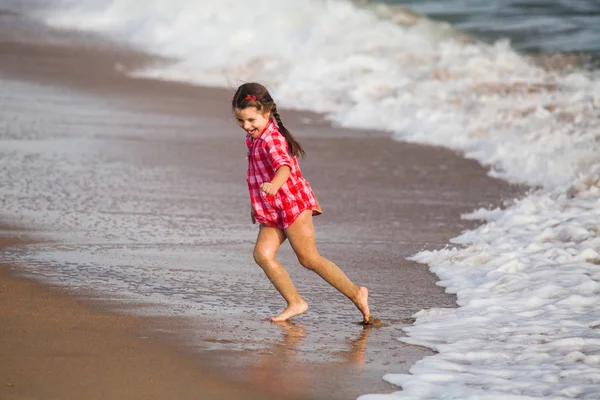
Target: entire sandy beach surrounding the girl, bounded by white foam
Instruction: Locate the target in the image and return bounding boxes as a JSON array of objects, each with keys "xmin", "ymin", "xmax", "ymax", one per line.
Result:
[{"xmin": 0, "ymin": 12, "xmax": 518, "ymax": 399}]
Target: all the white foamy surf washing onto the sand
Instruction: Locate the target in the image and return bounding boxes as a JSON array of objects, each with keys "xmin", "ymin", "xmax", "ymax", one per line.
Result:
[{"xmin": 10, "ymin": 0, "xmax": 600, "ymax": 400}]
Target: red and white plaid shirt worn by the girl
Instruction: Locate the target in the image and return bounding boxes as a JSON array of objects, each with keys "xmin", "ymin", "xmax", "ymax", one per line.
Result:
[{"xmin": 246, "ymin": 120, "xmax": 322, "ymax": 229}]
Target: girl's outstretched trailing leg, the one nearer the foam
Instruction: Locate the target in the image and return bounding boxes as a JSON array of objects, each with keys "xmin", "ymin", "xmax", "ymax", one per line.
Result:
[{"xmin": 285, "ymin": 210, "xmax": 371, "ymax": 322}]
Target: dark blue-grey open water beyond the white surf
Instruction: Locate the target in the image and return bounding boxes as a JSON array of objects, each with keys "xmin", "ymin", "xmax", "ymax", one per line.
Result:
[{"xmin": 377, "ymin": 0, "xmax": 600, "ymax": 54}]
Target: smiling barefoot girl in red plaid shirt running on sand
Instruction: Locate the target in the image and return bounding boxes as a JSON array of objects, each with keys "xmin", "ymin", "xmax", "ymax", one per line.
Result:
[{"xmin": 231, "ymin": 83, "xmax": 370, "ymax": 324}]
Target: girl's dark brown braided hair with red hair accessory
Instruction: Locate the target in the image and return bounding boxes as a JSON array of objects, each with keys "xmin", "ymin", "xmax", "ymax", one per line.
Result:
[{"xmin": 231, "ymin": 82, "xmax": 306, "ymax": 157}]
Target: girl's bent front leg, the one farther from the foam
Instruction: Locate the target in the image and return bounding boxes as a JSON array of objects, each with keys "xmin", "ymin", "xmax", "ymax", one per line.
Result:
[{"xmin": 254, "ymin": 224, "xmax": 308, "ymax": 322}]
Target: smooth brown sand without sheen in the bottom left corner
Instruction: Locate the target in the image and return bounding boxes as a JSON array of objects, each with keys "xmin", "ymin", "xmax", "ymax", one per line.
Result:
[{"xmin": 0, "ymin": 265, "xmax": 293, "ymax": 400}]
